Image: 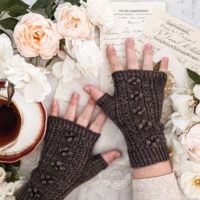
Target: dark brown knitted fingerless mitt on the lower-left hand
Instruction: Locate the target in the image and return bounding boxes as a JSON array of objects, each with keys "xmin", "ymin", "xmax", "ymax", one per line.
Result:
[{"xmin": 16, "ymin": 116, "xmax": 108, "ymax": 200}]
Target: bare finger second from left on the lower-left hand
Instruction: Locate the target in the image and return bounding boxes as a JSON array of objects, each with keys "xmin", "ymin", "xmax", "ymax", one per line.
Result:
[{"xmin": 64, "ymin": 93, "xmax": 80, "ymax": 121}]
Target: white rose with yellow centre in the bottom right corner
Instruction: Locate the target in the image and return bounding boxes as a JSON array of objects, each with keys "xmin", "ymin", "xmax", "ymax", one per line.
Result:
[{"xmin": 180, "ymin": 162, "xmax": 200, "ymax": 199}]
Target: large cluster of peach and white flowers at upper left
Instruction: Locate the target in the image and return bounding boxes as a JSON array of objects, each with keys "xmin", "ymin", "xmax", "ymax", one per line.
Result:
[{"xmin": 0, "ymin": 0, "xmax": 114, "ymax": 102}]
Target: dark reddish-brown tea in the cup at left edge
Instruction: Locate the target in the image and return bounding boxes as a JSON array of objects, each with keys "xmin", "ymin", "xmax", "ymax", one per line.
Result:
[{"xmin": 0, "ymin": 99, "xmax": 22, "ymax": 147}]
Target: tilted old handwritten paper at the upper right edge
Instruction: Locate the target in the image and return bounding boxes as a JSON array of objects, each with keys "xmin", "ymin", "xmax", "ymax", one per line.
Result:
[{"xmin": 137, "ymin": 9, "xmax": 200, "ymax": 74}]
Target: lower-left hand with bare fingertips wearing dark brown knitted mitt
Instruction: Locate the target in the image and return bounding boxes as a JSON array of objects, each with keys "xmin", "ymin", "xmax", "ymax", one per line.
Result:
[{"xmin": 17, "ymin": 94, "xmax": 121, "ymax": 200}]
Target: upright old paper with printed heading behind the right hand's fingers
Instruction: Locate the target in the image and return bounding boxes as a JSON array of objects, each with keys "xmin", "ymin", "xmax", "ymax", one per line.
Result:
[{"xmin": 100, "ymin": 2, "xmax": 165, "ymax": 93}]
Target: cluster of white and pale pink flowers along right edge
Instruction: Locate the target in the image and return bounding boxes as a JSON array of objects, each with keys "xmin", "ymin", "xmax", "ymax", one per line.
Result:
[{"xmin": 166, "ymin": 69, "xmax": 200, "ymax": 198}]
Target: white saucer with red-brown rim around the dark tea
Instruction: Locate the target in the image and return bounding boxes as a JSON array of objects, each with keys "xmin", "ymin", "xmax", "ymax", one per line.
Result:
[{"xmin": 0, "ymin": 82, "xmax": 47, "ymax": 162}]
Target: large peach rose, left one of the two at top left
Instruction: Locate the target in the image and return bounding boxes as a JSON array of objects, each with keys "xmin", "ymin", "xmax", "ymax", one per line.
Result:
[{"xmin": 13, "ymin": 13, "xmax": 60, "ymax": 59}]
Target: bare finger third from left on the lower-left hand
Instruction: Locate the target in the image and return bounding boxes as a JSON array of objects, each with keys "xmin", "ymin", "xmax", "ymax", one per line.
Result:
[{"xmin": 77, "ymin": 98, "xmax": 96, "ymax": 127}]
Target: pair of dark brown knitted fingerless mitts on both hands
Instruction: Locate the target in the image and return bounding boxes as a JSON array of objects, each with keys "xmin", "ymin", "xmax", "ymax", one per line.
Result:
[{"xmin": 17, "ymin": 70, "xmax": 169, "ymax": 200}]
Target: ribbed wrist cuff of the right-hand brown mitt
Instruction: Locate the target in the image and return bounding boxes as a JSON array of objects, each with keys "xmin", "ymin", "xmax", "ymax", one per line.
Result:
[{"xmin": 128, "ymin": 143, "xmax": 169, "ymax": 168}]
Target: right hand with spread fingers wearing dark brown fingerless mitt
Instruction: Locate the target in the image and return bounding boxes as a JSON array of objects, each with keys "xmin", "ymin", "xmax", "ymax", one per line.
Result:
[{"xmin": 84, "ymin": 38, "xmax": 171, "ymax": 178}]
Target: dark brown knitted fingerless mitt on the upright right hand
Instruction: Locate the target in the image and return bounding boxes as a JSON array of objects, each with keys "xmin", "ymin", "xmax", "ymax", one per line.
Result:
[{"xmin": 97, "ymin": 70, "xmax": 169, "ymax": 168}]
